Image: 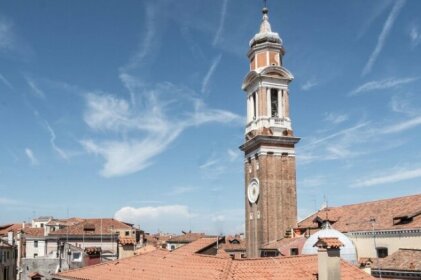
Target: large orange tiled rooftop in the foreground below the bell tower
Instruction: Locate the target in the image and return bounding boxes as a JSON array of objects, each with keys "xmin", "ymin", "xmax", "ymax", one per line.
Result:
[{"xmin": 57, "ymin": 238, "xmax": 373, "ymax": 280}]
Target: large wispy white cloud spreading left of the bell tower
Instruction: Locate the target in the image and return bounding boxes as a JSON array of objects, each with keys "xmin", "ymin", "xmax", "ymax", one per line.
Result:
[{"xmin": 81, "ymin": 83, "xmax": 243, "ymax": 177}]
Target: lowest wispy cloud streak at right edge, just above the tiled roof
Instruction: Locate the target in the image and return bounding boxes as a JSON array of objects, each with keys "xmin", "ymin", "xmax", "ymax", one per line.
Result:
[{"xmin": 351, "ymin": 168, "xmax": 421, "ymax": 188}]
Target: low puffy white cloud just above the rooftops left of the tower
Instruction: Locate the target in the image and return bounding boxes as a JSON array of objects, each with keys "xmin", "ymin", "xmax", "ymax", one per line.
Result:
[{"xmin": 114, "ymin": 205, "xmax": 195, "ymax": 232}]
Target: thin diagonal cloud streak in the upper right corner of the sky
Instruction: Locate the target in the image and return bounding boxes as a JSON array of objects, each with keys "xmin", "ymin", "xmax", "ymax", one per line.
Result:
[{"xmin": 362, "ymin": 0, "xmax": 406, "ymax": 76}]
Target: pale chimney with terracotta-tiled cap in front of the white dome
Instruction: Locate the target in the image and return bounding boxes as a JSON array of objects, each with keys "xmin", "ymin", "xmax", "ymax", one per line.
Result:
[{"xmin": 314, "ymin": 237, "xmax": 343, "ymax": 280}]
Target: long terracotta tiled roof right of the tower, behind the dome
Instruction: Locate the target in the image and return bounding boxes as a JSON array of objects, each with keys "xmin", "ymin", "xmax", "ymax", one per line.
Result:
[{"xmin": 298, "ymin": 194, "xmax": 421, "ymax": 232}]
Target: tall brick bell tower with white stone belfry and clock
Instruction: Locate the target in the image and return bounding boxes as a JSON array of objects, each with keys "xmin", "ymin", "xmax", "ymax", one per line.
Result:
[{"xmin": 240, "ymin": 7, "xmax": 300, "ymax": 258}]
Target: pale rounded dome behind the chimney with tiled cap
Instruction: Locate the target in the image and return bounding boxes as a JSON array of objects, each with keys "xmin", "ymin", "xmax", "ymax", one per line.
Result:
[{"xmin": 302, "ymin": 222, "xmax": 357, "ymax": 264}]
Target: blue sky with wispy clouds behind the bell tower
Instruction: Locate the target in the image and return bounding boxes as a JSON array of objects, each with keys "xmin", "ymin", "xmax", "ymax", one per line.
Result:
[{"xmin": 0, "ymin": 0, "xmax": 421, "ymax": 233}]
